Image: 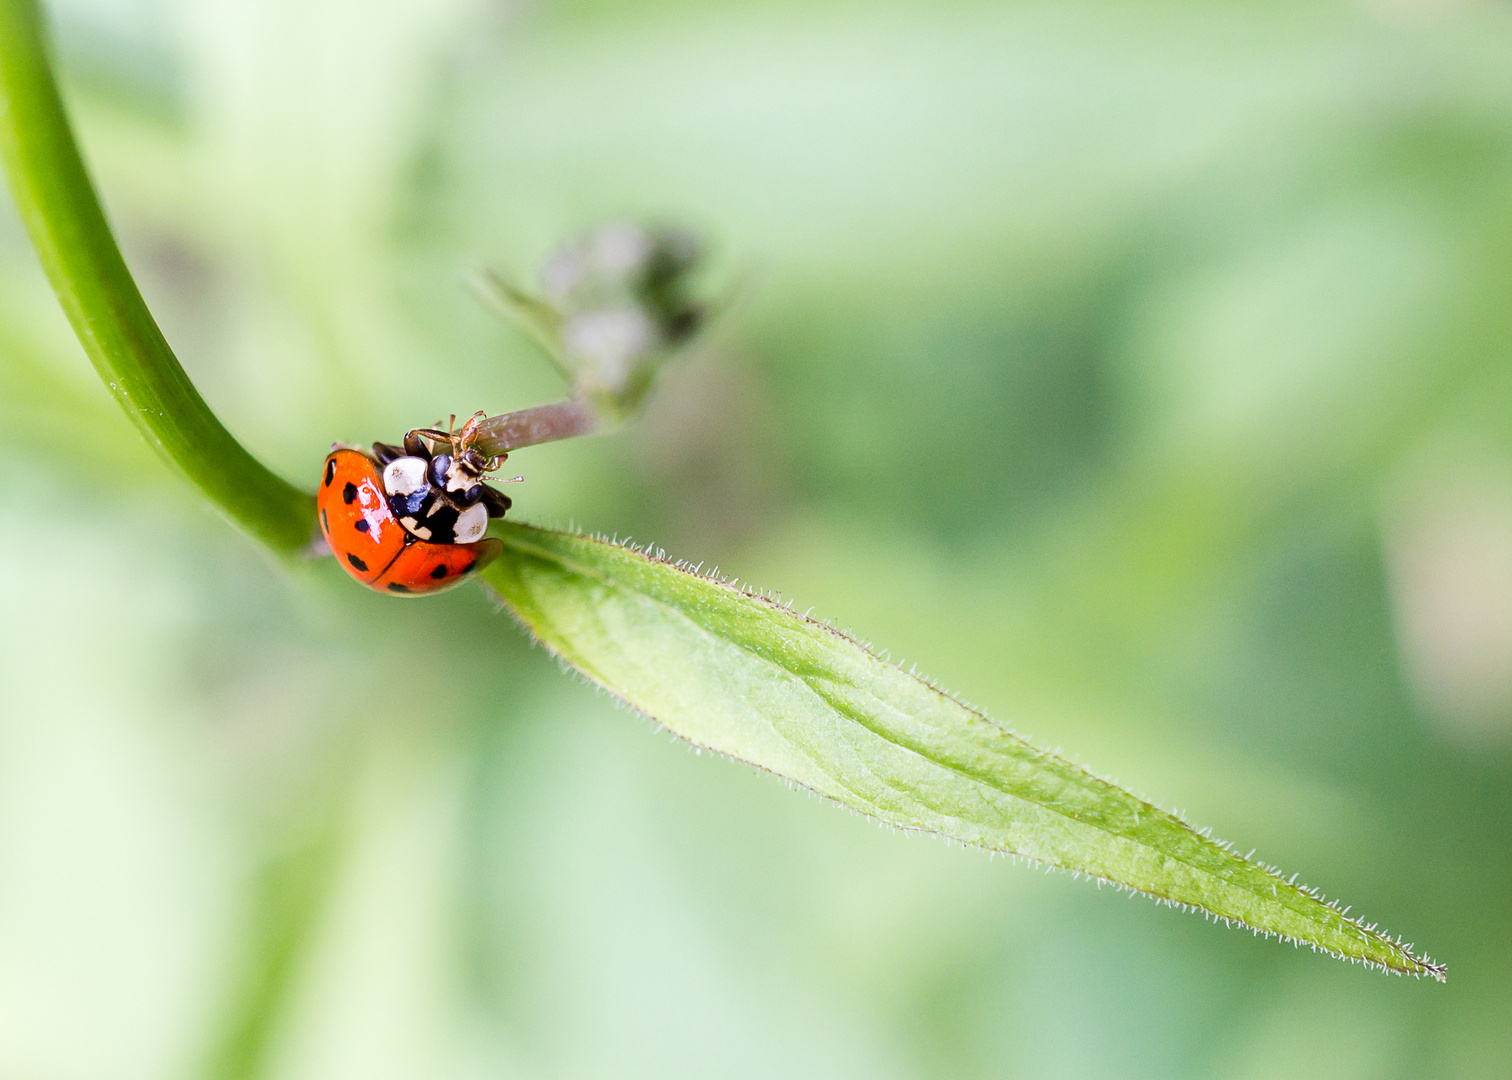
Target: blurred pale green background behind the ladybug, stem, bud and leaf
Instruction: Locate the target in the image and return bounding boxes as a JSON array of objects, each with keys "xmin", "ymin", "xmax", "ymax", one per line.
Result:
[{"xmin": 0, "ymin": 0, "xmax": 1512, "ymax": 1080}]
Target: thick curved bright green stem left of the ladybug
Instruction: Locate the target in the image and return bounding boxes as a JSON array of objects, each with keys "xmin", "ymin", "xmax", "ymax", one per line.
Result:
[{"xmin": 0, "ymin": 0, "xmax": 314, "ymax": 557}]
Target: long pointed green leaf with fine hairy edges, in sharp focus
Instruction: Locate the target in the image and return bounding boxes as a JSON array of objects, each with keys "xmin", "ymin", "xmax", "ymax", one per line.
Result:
[{"xmin": 484, "ymin": 523, "xmax": 1444, "ymax": 980}]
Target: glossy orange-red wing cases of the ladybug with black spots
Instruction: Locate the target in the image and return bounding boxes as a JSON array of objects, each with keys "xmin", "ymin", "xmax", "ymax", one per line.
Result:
[{"xmin": 316, "ymin": 449, "xmax": 503, "ymax": 596}]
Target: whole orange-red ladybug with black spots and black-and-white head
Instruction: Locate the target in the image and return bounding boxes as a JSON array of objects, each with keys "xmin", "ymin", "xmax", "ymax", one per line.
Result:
[{"xmin": 316, "ymin": 413, "xmax": 510, "ymax": 596}]
